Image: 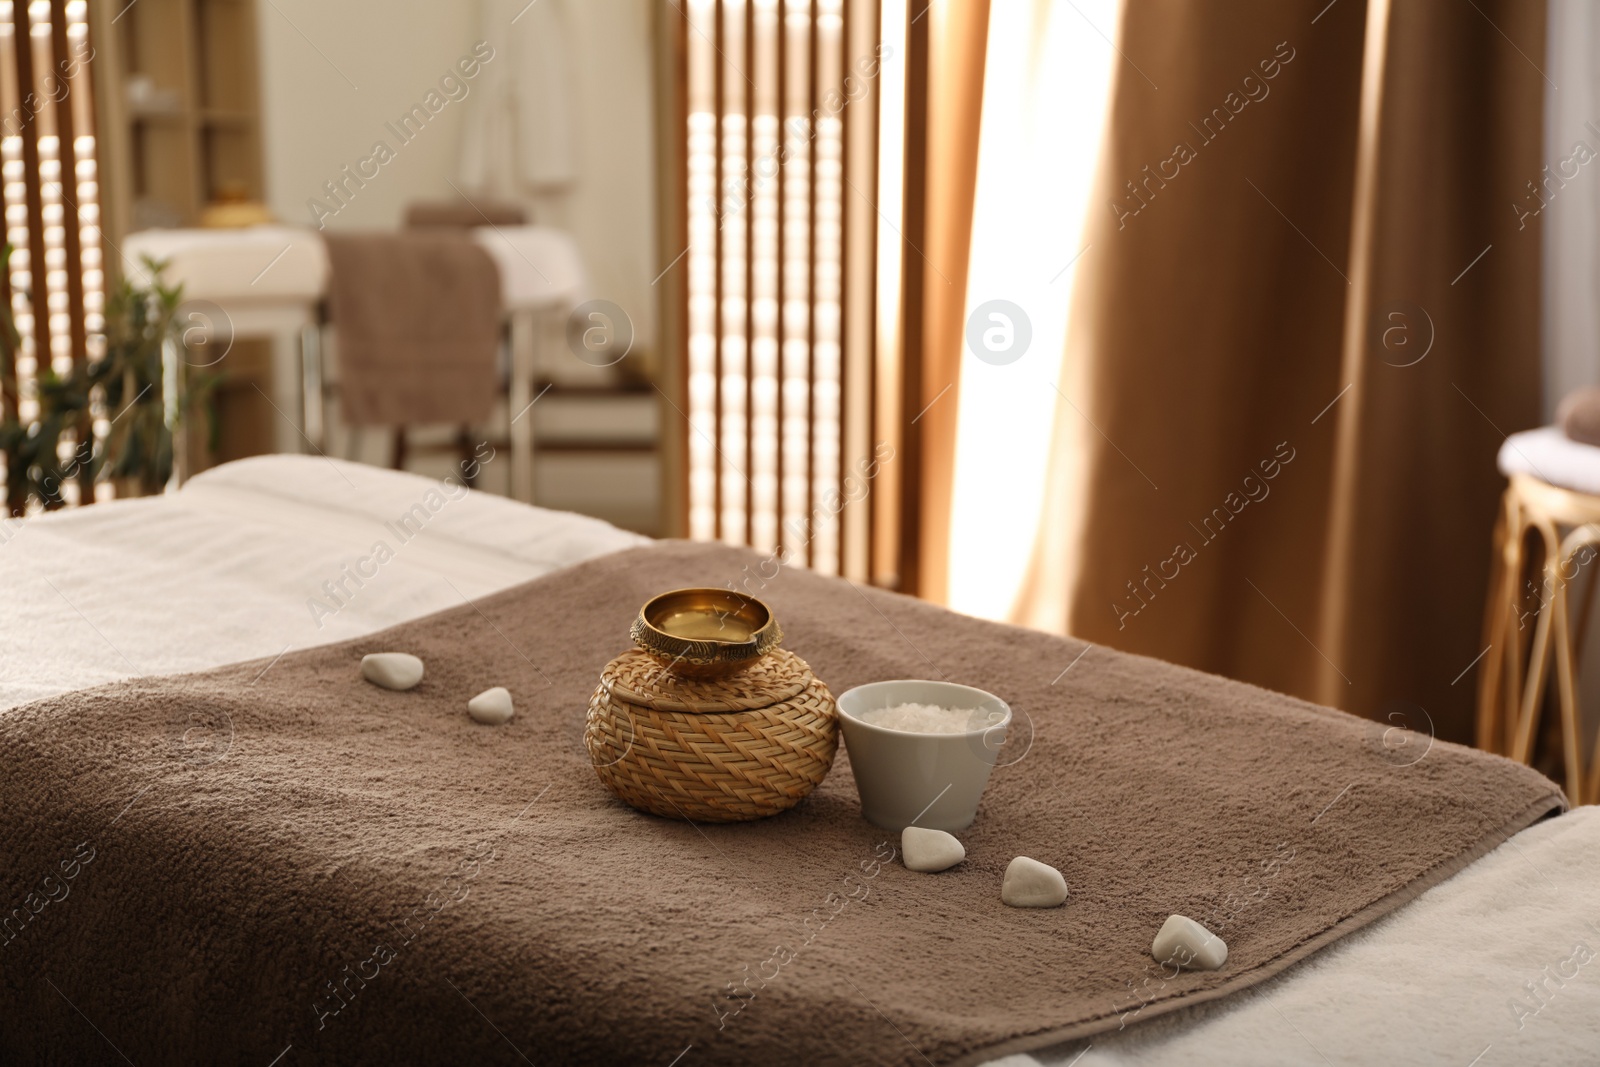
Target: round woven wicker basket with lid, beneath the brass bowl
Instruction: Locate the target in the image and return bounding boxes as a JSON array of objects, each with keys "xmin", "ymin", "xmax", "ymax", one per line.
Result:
[{"xmin": 584, "ymin": 648, "xmax": 838, "ymax": 822}]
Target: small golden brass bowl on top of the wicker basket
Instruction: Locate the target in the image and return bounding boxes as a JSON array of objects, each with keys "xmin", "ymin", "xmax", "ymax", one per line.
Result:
[{"xmin": 630, "ymin": 589, "xmax": 784, "ymax": 677}]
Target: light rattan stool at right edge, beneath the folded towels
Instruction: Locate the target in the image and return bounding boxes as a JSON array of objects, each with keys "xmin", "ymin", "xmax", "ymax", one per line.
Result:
[{"xmin": 1478, "ymin": 462, "xmax": 1600, "ymax": 805}]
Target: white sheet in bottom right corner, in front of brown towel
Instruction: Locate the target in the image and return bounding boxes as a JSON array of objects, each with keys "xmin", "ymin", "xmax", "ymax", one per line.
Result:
[{"xmin": 1011, "ymin": 808, "xmax": 1600, "ymax": 1067}]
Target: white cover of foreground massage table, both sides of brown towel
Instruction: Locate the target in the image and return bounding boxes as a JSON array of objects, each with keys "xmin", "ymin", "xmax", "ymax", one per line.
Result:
[{"xmin": 0, "ymin": 456, "xmax": 1600, "ymax": 1067}]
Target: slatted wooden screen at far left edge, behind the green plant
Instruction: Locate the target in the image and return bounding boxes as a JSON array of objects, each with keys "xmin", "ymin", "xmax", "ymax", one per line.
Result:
[{"xmin": 0, "ymin": 0, "xmax": 104, "ymax": 515}]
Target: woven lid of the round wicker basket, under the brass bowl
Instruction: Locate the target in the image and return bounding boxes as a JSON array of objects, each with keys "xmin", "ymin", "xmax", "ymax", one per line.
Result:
[{"xmin": 600, "ymin": 648, "xmax": 813, "ymax": 712}]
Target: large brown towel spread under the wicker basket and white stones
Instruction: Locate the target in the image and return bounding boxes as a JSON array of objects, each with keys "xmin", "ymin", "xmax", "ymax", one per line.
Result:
[{"xmin": 0, "ymin": 542, "xmax": 1561, "ymax": 1067}]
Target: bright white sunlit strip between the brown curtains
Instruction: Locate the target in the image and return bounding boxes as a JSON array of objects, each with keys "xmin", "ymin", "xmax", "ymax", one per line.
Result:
[{"xmin": 949, "ymin": 0, "xmax": 1117, "ymax": 619}]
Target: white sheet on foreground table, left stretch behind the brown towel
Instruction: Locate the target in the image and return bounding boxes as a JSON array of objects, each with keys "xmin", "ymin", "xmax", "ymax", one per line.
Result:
[{"xmin": 0, "ymin": 456, "xmax": 648, "ymax": 709}]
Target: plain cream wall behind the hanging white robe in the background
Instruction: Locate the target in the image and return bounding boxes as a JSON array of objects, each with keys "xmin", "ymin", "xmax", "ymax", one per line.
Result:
[{"xmin": 256, "ymin": 0, "xmax": 661, "ymax": 350}]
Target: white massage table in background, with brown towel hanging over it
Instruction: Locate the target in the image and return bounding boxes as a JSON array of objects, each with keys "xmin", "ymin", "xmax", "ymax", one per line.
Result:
[{"xmin": 120, "ymin": 224, "xmax": 587, "ymax": 502}]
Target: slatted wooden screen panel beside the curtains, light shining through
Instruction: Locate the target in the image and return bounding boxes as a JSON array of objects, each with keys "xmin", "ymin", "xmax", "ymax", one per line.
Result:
[{"xmin": 667, "ymin": 0, "xmax": 901, "ymax": 579}]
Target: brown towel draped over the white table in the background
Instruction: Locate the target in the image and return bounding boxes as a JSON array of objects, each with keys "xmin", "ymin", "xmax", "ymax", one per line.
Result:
[{"xmin": 325, "ymin": 234, "xmax": 501, "ymax": 426}]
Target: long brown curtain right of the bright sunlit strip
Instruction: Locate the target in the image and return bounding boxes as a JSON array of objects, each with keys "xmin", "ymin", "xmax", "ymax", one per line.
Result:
[{"xmin": 1018, "ymin": 0, "xmax": 1544, "ymax": 741}]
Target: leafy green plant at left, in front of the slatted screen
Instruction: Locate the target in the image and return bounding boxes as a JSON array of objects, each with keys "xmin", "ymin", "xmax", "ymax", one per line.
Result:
[{"xmin": 0, "ymin": 254, "xmax": 221, "ymax": 514}]
